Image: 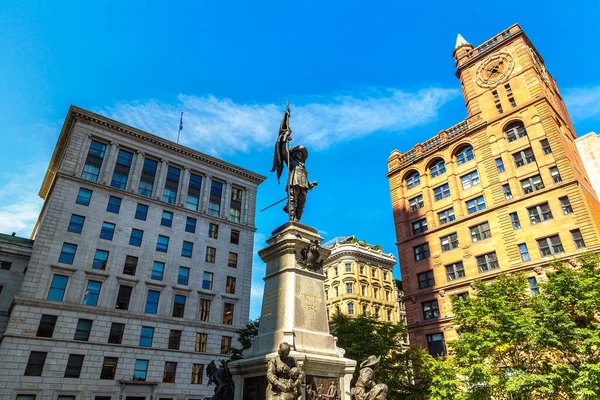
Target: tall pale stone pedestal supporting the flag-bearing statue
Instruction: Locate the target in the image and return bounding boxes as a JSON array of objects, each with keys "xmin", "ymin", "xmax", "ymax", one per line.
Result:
[{"xmin": 229, "ymin": 222, "xmax": 356, "ymax": 400}]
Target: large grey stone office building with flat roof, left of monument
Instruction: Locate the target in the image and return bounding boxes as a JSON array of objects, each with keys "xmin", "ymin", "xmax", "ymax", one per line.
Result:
[{"xmin": 0, "ymin": 107, "xmax": 264, "ymax": 400}]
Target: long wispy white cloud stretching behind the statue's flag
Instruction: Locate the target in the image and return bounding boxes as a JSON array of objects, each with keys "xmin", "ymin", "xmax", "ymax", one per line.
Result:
[{"xmin": 97, "ymin": 88, "xmax": 459, "ymax": 155}]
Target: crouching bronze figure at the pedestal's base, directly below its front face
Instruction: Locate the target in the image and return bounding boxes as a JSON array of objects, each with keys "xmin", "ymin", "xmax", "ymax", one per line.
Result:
[{"xmin": 265, "ymin": 342, "xmax": 304, "ymax": 400}]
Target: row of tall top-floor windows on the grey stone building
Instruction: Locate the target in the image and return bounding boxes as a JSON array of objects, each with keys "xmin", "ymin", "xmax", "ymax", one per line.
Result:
[{"xmin": 81, "ymin": 140, "xmax": 243, "ymax": 223}]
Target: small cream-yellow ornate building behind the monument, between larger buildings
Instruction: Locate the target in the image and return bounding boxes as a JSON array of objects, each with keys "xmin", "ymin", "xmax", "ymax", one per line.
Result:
[{"xmin": 323, "ymin": 236, "xmax": 403, "ymax": 323}]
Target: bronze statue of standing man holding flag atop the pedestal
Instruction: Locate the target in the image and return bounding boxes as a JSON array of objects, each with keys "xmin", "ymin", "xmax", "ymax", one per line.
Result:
[{"xmin": 269, "ymin": 104, "xmax": 318, "ymax": 222}]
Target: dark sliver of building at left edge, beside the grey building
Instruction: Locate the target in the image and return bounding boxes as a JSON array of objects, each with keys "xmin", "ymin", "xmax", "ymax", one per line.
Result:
[{"xmin": 0, "ymin": 233, "xmax": 33, "ymax": 337}]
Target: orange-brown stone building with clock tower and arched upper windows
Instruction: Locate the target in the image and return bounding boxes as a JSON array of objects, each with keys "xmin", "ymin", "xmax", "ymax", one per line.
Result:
[{"xmin": 387, "ymin": 25, "xmax": 600, "ymax": 354}]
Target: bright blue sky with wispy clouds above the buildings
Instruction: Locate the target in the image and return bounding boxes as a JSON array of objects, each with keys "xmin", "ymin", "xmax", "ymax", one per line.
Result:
[{"xmin": 0, "ymin": 0, "xmax": 600, "ymax": 317}]
